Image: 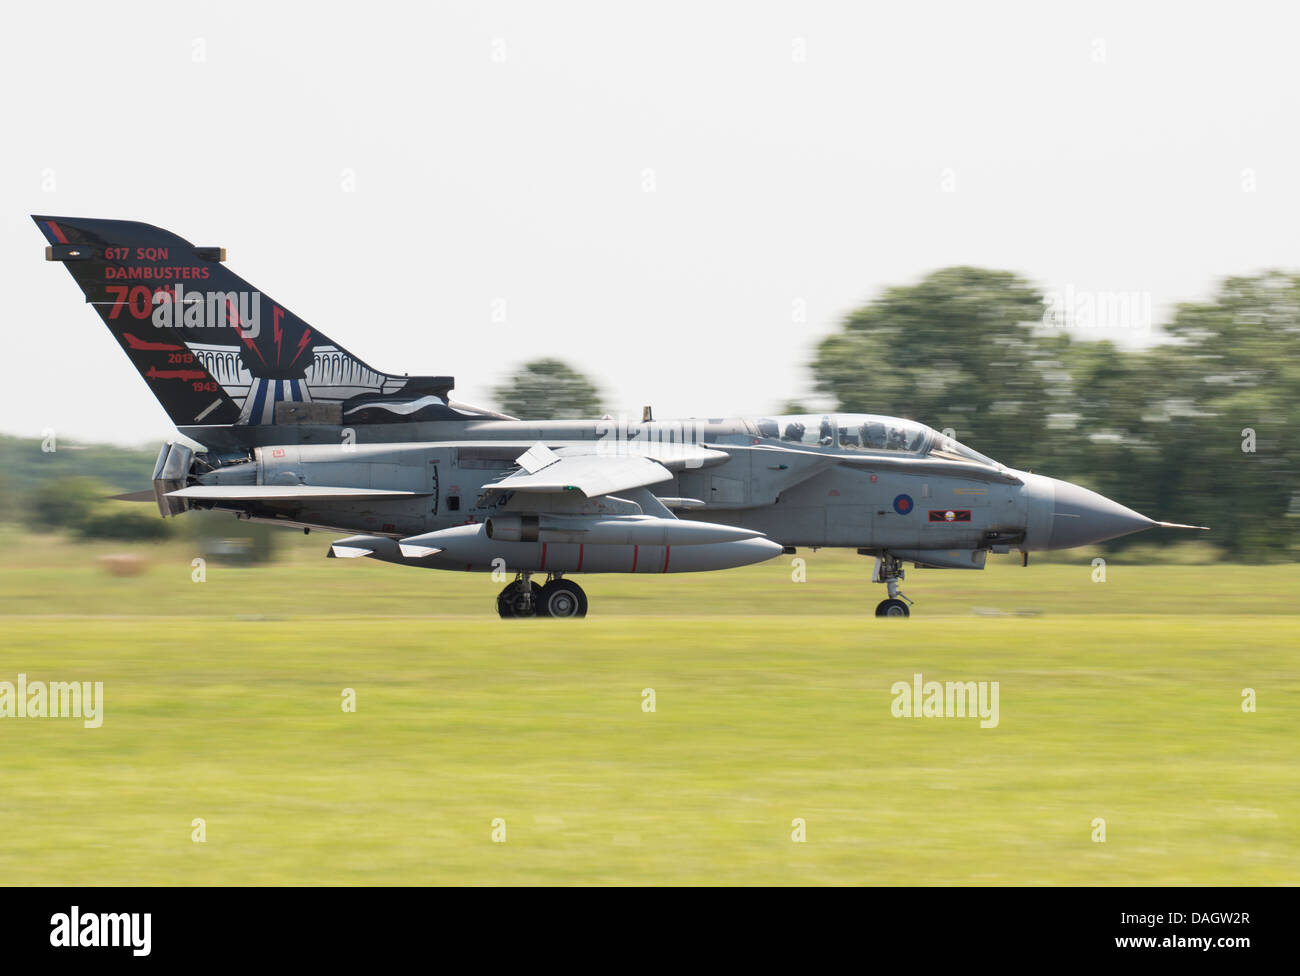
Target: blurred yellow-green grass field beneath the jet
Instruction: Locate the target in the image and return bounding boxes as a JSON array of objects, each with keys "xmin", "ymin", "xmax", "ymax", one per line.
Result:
[{"xmin": 0, "ymin": 533, "xmax": 1300, "ymax": 885}]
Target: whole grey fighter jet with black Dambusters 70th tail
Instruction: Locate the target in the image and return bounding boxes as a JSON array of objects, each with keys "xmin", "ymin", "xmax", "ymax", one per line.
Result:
[{"xmin": 34, "ymin": 217, "xmax": 1200, "ymax": 617}]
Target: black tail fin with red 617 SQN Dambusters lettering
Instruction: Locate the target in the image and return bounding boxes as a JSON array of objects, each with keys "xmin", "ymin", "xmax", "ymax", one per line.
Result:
[{"xmin": 33, "ymin": 216, "xmax": 468, "ymax": 428}]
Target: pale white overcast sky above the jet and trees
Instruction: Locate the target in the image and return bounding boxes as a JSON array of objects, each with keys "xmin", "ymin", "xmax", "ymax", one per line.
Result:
[{"xmin": 0, "ymin": 0, "xmax": 1300, "ymax": 443}]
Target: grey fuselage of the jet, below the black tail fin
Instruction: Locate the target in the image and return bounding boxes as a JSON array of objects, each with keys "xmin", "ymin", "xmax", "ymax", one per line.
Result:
[{"xmin": 172, "ymin": 420, "xmax": 1152, "ymax": 573}]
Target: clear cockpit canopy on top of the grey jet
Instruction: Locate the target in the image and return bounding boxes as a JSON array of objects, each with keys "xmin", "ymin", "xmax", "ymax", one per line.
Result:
[{"xmin": 753, "ymin": 413, "xmax": 1001, "ymax": 468}]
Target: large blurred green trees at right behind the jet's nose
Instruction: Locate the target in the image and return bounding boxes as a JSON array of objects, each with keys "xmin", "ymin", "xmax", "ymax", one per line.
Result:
[{"xmin": 813, "ymin": 268, "xmax": 1300, "ymax": 559}]
